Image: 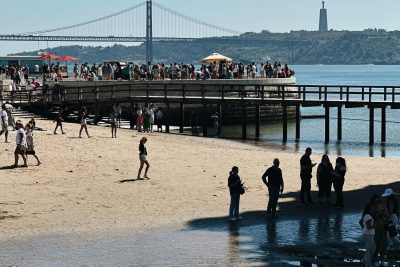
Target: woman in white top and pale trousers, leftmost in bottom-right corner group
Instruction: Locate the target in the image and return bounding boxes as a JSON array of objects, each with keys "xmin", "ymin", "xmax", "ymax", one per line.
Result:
[{"xmin": 360, "ymin": 203, "xmax": 376, "ymax": 267}]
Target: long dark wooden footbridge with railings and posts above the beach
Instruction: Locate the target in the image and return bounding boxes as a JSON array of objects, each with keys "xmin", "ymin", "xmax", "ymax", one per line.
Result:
[{"xmin": 0, "ymin": 80, "xmax": 400, "ymax": 145}]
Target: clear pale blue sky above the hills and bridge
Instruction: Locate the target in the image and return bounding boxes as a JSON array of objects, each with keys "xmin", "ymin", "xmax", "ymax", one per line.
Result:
[{"xmin": 0, "ymin": 0, "xmax": 400, "ymax": 55}]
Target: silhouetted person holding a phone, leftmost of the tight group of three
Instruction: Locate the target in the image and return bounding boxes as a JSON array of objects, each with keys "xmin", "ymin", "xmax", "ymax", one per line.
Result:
[{"xmin": 300, "ymin": 147, "xmax": 316, "ymax": 205}]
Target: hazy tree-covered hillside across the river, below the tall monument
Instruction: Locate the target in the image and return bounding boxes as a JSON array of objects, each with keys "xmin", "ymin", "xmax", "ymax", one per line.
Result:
[{"xmin": 10, "ymin": 29, "xmax": 400, "ymax": 64}]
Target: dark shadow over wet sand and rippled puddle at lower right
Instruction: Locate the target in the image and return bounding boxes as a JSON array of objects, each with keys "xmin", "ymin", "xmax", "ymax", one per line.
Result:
[{"xmin": 188, "ymin": 182, "xmax": 400, "ymax": 266}]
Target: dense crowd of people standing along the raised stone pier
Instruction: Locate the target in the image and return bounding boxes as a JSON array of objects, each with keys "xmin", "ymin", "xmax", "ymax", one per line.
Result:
[{"xmin": 61, "ymin": 61, "xmax": 295, "ymax": 81}]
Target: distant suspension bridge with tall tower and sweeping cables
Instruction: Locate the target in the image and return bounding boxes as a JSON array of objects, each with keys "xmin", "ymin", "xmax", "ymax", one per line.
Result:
[{"xmin": 0, "ymin": 0, "xmax": 240, "ymax": 61}]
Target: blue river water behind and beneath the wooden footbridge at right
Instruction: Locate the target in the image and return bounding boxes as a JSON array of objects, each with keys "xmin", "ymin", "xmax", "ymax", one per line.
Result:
[{"xmin": 223, "ymin": 65, "xmax": 400, "ymax": 157}]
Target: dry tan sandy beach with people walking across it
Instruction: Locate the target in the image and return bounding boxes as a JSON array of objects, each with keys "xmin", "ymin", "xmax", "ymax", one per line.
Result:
[{"xmin": 0, "ymin": 119, "xmax": 400, "ymax": 241}]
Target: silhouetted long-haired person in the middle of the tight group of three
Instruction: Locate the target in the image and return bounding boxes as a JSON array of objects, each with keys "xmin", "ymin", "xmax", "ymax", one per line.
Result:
[{"xmin": 317, "ymin": 154, "xmax": 333, "ymax": 205}]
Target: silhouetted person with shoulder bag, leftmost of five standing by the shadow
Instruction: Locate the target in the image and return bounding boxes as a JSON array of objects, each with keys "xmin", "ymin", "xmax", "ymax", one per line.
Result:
[{"xmin": 228, "ymin": 166, "xmax": 242, "ymax": 221}]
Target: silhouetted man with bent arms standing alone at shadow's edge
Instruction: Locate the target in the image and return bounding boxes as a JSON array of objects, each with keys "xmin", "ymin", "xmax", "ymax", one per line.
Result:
[{"xmin": 262, "ymin": 159, "xmax": 284, "ymax": 217}]
